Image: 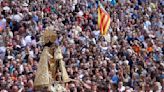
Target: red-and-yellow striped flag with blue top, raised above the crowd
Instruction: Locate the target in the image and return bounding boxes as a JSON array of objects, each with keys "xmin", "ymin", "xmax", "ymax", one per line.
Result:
[{"xmin": 98, "ymin": 2, "xmax": 110, "ymax": 35}]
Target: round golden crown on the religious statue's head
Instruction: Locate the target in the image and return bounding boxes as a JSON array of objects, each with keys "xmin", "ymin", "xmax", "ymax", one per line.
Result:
[{"xmin": 41, "ymin": 28, "xmax": 57, "ymax": 45}]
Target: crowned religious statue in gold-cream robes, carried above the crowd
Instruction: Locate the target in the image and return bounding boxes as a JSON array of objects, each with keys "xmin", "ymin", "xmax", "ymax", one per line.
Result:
[{"xmin": 34, "ymin": 29, "xmax": 71, "ymax": 92}]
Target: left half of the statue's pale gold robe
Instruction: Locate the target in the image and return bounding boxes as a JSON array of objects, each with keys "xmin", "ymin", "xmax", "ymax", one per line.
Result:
[{"xmin": 34, "ymin": 47, "xmax": 52, "ymax": 87}]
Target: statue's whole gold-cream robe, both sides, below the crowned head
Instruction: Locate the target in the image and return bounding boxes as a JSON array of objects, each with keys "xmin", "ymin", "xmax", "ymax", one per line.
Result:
[{"xmin": 34, "ymin": 47, "xmax": 70, "ymax": 87}]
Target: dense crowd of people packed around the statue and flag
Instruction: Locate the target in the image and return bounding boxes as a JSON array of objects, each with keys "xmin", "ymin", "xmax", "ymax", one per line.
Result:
[{"xmin": 0, "ymin": 0, "xmax": 164, "ymax": 92}]
